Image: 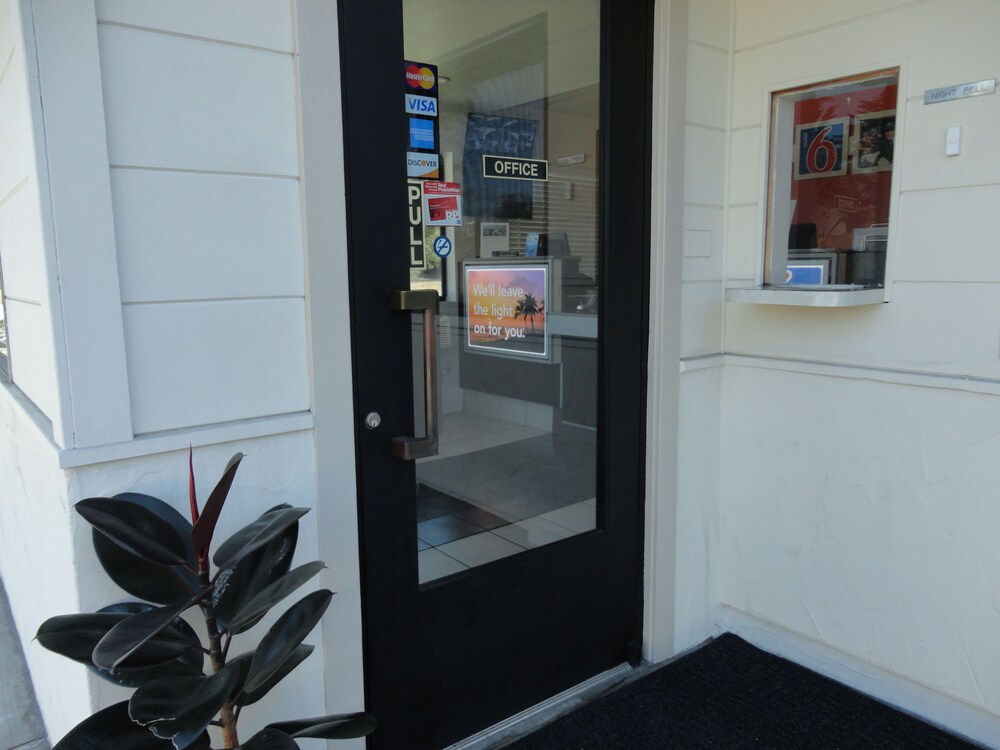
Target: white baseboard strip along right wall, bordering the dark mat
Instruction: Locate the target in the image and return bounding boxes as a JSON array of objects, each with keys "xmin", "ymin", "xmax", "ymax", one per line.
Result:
[{"xmin": 720, "ymin": 605, "xmax": 1000, "ymax": 747}]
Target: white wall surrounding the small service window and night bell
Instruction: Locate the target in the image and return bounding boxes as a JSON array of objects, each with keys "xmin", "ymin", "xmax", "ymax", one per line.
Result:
[{"xmin": 716, "ymin": 0, "xmax": 1000, "ymax": 744}]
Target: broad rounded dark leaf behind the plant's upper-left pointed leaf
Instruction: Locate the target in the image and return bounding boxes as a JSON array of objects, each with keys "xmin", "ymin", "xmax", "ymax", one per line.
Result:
[{"xmin": 93, "ymin": 492, "xmax": 199, "ymax": 604}]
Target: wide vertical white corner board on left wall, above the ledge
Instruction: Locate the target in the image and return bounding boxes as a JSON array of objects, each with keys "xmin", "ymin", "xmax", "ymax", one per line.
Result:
[{"xmin": 22, "ymin": 0, "xmax": 132, "ymax": 448}]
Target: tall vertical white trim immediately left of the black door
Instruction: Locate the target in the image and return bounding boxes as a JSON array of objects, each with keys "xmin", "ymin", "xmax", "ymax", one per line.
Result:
[{"xmin": 292, "ymin": 0, "xmax": 365, "ymax": 736}]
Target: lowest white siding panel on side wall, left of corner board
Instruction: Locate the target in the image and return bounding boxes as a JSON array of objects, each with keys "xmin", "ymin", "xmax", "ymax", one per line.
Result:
[{"xmin": 7, "ymin": 299, "xmax": 58, "ymax": 414}]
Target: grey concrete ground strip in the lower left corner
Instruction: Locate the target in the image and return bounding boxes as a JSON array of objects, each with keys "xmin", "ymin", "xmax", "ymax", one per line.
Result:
[{"xmin": 0, "ymin": 582, "xmax": 49, "ymax": 750}]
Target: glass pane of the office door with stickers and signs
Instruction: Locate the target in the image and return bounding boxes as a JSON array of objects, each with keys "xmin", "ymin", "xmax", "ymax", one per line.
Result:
[{"xmin": 400, "ymin": 0, "xmax": 600, "ymax": 582}]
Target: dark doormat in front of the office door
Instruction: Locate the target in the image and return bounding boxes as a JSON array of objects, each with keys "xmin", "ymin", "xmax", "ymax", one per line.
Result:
[{"xmin": 505, "ymin": 634, "xmax": 976, "ymax": 750}]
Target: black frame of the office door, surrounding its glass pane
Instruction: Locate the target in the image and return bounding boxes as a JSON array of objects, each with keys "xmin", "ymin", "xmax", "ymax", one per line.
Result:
[{"xmin": 340, "ymin": 0, "xmax": 653, "ymax": 749}]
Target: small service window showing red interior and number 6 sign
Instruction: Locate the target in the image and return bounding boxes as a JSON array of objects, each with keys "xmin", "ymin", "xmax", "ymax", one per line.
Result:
[{"xmin": 764, "ymin": 69, "xmax": 899, "ymax": 289}]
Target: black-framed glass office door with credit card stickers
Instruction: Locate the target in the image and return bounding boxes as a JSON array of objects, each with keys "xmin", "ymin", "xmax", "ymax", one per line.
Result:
[{"xmin": 340, "ymin": 0, "xmax": 652, "ymax": 750}]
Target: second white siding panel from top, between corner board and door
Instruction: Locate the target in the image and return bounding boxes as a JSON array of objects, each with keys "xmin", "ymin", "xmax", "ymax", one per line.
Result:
[{"xmin": 100, "ymin": 26, "xmax": 298, "ymax": 175}]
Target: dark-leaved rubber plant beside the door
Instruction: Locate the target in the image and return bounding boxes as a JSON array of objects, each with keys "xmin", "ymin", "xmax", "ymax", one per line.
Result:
[{"xmin": 37, "ymin": 453, "xmax": 375, "ymax": 750}]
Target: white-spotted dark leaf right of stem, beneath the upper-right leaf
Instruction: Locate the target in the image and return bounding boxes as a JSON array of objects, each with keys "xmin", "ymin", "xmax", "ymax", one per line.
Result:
[{"xmin": 212, "ymin": 503, "xmax": 299, "ymax": 630}]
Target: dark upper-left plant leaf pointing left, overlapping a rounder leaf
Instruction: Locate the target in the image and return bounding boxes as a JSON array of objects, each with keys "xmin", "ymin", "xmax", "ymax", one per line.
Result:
[{"xmin": 74, "ymin": 497, "xmax": 187, "ymax": 565}]
